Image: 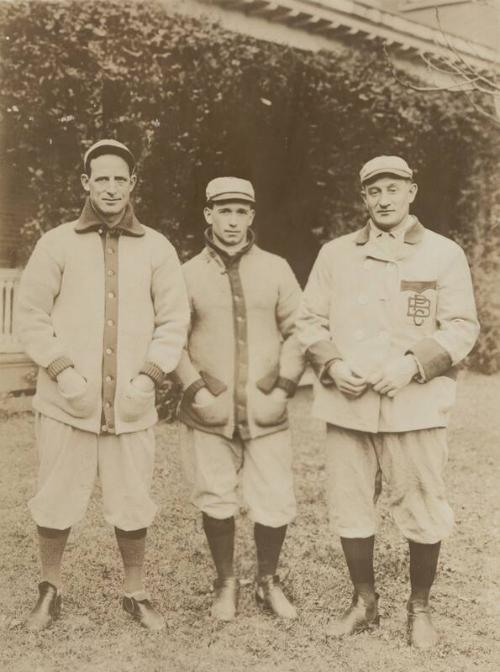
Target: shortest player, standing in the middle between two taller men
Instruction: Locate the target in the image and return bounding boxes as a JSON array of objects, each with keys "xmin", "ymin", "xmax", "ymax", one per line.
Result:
[{"xmin": 177, "ymin": 177, "xmax": 303, "ymax": 621}]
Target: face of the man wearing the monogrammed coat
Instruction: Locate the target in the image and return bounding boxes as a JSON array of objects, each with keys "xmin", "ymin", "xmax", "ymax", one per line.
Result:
[{"xmin": 361, "ymin": 175, "xmax": 417, "ymax": 231}]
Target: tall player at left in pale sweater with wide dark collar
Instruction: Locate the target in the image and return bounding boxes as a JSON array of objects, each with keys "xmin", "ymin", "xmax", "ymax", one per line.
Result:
[{"xmin": 18, "ymin": 140, "xmax": 189, "ymax": 630}]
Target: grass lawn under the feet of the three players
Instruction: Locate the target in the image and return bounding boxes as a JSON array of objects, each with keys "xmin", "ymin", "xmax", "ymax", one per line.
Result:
[{"xmin": 0, "ymin": 374, "xmax": 500, "ymax": 672}]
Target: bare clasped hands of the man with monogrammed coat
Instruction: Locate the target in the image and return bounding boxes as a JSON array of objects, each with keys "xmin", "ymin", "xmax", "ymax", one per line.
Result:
[{"xmin": 328, "ymin": 355, "xmax": 418, "ymax": 399}]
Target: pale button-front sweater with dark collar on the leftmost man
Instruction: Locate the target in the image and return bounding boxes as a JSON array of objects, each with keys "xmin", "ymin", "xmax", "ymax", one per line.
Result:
[{"xmin": 17, "ymin": 201, "xmax": 189, "ymax": 434}]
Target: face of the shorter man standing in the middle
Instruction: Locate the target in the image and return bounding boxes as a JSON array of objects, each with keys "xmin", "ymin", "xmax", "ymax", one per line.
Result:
[{"xmin": 204, "ymin": 201, "xmax": 255, "ymax": 247}]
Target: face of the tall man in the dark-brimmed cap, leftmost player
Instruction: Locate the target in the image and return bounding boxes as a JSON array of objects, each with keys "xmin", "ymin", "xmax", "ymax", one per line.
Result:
[{"xmin": 81, "ymin": 154, "xmax": 136, "ymax": 219}]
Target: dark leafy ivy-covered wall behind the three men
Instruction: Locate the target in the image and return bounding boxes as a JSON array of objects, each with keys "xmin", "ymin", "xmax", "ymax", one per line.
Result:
[{"xmin": 0, "ymin": 0, "xmax": 500, "ymax": 371}]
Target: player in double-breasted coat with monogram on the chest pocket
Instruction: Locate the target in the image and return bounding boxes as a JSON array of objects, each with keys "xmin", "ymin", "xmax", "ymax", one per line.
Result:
[{"xmin": 297, "ymin": 156, "xmax": 479, "ymax": 648}]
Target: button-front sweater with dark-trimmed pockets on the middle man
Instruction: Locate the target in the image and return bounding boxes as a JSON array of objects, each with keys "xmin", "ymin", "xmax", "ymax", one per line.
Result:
[{"xmin": 176, "ymin": 232, "xmax": 304, "ymax": 439}]
